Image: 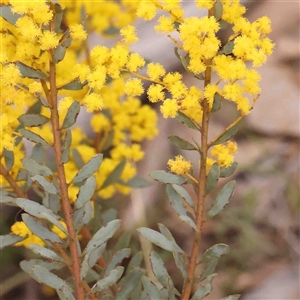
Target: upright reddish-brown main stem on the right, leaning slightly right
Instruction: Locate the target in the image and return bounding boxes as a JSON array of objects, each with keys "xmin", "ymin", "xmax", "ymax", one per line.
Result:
[{"xmin": 181, "ymin": 9, "xmax": 213, "ymax": 300}]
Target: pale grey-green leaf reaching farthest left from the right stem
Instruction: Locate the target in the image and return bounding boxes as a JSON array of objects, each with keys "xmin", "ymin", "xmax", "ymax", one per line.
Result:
[{"xmin": 137, "ymin": 227, "xmax": 184, "ymax": 253}]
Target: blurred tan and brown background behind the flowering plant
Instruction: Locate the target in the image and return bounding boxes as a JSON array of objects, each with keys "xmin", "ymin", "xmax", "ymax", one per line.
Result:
[{"xmin": 0, "ymin": 1, "xmax": 300, "ymax": 300}]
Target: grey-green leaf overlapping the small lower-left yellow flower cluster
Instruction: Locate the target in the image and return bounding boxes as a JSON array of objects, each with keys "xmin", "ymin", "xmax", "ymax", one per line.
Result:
[{"xmin": 22, "ymin": 214, "xmax": 63, "ymax": 244}]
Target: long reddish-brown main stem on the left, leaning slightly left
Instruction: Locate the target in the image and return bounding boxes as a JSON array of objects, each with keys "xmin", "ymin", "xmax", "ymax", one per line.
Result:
[{"xmin": 48, "ymin": 8, "xmax": 84, "ymax": 300}]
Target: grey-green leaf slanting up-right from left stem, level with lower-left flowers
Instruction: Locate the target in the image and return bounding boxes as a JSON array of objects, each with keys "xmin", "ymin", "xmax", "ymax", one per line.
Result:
[{"xmin": 84, "ymin": 220, "xmax": 121, "ymax": 253}]
